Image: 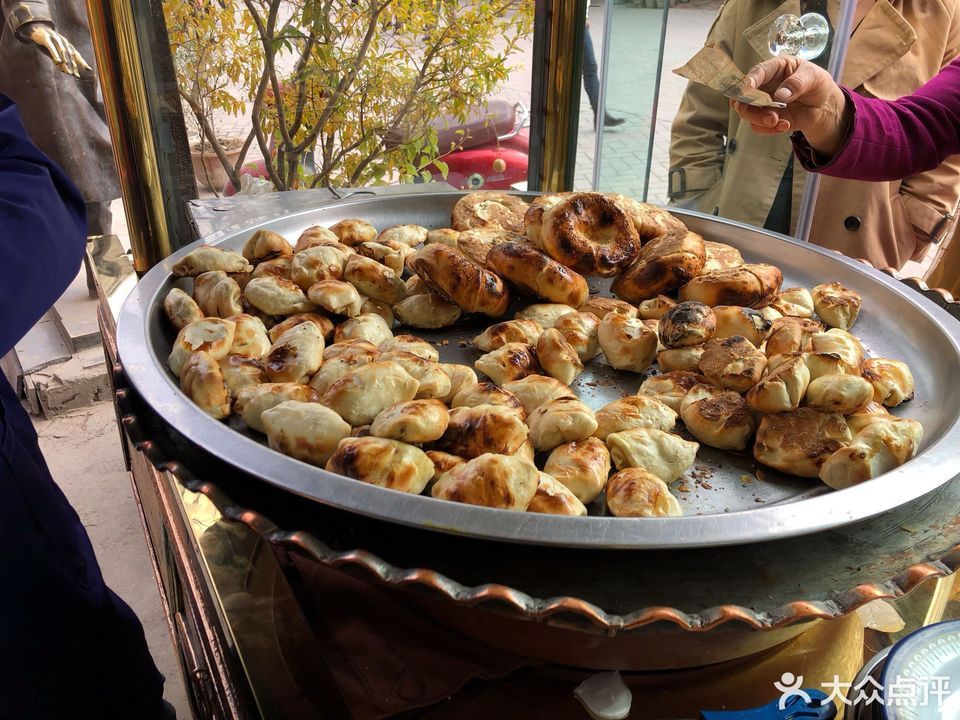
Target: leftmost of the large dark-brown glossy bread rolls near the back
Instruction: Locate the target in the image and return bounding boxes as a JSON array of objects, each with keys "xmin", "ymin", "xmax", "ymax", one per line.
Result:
[{"xmin": 410, "ymin": 243, "xmax": 510, "ymax": 317}]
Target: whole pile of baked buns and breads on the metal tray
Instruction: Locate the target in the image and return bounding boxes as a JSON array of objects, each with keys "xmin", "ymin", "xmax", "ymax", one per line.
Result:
[{"xmin": 164, "ymin": 193, "xmax": 922, "ymax": 517}]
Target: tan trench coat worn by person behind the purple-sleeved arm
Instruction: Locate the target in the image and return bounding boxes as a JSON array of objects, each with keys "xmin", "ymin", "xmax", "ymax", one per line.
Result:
[{"xmin": 670, "ymin": 0, "xmax": 960, "ymax": 268}]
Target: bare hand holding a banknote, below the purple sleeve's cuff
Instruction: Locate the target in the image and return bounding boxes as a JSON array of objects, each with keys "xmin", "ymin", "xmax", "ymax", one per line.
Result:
[{"xmin": 733, "ymin": 57, "xmax": 849, "ymax": 157}]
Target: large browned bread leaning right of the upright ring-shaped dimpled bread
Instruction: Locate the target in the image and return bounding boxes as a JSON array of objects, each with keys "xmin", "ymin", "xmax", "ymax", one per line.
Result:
[{"xmin": 610, "ymin": 230, "xmax": 709, "ymax": 304}]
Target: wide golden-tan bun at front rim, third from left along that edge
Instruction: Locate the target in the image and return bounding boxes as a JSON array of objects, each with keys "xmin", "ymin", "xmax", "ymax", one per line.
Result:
[{"xmin": 430, "ymin": 453, "xmax": 540, "ymax": 510}]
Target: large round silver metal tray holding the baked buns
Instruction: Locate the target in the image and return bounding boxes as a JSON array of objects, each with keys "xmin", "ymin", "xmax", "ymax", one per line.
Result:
[{"xmin": 118, "ymin": 192, "xmax": 960, "ymax": 548}]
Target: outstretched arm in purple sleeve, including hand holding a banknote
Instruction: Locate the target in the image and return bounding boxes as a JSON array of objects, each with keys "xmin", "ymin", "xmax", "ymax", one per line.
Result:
[{"xmin": 733, "ymin": 57, "xmax": 960, "ymax": 181}]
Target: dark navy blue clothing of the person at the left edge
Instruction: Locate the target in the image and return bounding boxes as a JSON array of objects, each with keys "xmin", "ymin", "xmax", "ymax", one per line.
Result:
[{"xmin": 0, "ymin": 95, "xmax": 163, "ymax": 720}]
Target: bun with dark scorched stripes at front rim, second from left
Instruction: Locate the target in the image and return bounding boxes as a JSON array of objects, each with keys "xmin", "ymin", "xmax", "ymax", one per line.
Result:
[{"xmin": 326, "ymin": 437, "xmax": 433, "ymax": 495}]
